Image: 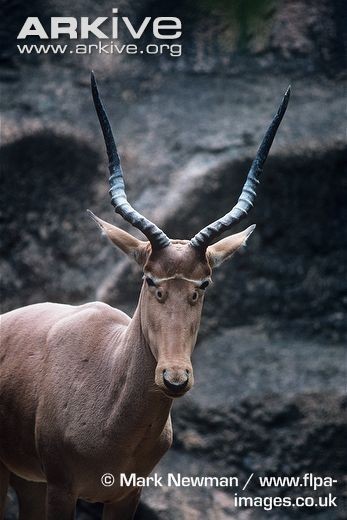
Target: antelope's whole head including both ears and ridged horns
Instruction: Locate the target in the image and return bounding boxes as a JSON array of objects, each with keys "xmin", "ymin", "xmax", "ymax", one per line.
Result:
[{"xmin": 88, "ymin": 73, "xmax": 290, "ymax": 397}]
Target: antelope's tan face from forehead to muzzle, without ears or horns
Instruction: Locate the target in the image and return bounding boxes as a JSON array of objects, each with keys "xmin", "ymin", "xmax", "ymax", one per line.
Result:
[{"xmin": 141, "ymin": 240, "xmax": 211, "ymax": 397}]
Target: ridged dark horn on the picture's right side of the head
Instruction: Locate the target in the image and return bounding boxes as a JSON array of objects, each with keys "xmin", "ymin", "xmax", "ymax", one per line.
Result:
[{"xmin": 190, "ymin": 86, "xmax": 290, "ymax": 249}]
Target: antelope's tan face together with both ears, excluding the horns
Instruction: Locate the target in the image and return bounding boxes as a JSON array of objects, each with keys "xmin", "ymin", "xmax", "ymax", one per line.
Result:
[{"xmin": 92, "ymin": 214, "xmax": 255, "ymax": 397}]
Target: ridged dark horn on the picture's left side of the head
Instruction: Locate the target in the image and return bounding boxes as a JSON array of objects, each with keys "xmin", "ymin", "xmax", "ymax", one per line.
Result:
[{"xmin": 91, "ymin": 72, "xmax": 170, "ymax": 250}]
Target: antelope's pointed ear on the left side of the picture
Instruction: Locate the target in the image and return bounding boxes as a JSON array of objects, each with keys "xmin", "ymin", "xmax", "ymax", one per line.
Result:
[{"xmin": 87, "ymin": 209, "xmax": 150, "ymax": 267}]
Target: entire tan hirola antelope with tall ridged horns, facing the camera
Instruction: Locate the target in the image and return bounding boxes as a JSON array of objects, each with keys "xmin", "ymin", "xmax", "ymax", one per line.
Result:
[{"xmin": 0, "ymin": 75, "xmax": 289, "ymax": 520}]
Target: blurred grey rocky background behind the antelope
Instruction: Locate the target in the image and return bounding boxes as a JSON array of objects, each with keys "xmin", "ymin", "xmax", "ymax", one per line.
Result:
[{"xmin": 0, "ymin": 0, "xmax": 347, "ymax": 520}]
